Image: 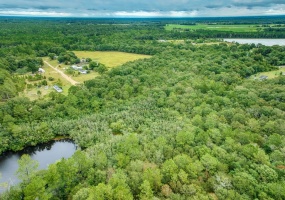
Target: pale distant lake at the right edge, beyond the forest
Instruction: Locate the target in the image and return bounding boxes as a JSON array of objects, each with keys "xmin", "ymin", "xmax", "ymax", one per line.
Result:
[{"xmin": 224, "ymin": 38, "xmax": 285, "ymax": 46}]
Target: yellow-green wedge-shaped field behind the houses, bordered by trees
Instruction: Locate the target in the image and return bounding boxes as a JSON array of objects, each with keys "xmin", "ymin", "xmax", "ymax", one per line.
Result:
[{"xmin": 74, "ymin": 51, "xmax": 151, "ymax": 68}]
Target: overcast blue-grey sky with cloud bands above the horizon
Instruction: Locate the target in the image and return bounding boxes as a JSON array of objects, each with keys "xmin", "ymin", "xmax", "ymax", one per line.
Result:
[{"xmin": 0, "ymin": 0, "xmax": 285, "ymax": 17}]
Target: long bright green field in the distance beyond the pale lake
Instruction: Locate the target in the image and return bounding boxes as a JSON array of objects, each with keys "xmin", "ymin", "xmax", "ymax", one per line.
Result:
[{"xmin": 165, "ymin": 24, "xmax": 262, "ymax": 32}]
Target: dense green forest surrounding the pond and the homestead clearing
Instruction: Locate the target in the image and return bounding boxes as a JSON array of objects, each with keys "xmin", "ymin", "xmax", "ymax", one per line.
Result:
[{"xmin": 0, "ymin": 18, "xmax": 285, "ymax": 200}]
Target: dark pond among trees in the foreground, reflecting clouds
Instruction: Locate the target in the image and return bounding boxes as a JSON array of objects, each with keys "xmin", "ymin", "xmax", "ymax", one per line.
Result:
[{"xmin": 0, "ymin": 139, "xmax": 76, "ymax": 193}]
